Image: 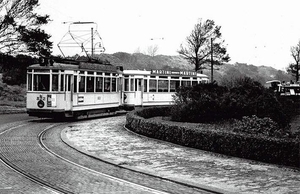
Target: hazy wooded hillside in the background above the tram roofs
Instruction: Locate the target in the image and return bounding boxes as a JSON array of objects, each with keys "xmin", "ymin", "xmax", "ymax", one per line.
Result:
[{"xmin": 98, "ymin": 52, "xmax": 292, "ymax": 84}]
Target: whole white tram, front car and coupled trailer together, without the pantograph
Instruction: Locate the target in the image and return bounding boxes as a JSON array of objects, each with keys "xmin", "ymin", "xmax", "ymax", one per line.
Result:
[{"xmin": 26, "ymin": 59, "xmax": 208, "ymax": 118}]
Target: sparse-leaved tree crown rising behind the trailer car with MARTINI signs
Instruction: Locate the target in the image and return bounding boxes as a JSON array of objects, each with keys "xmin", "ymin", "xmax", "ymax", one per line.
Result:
[{"xmin": 178, "ymin": 20, "xmax": 230, "ymax": 71}]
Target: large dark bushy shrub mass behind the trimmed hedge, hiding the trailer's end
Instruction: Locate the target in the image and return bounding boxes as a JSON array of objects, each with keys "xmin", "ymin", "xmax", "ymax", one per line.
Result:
[{"xmin": 171, "ymin": 77, "xmax": 296, "ymax": 128}]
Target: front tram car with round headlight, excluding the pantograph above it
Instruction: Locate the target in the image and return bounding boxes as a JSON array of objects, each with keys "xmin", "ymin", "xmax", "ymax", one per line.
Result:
[{"xmin": 26, "ymin": 59, "xmax": 122, "ymax": 118}]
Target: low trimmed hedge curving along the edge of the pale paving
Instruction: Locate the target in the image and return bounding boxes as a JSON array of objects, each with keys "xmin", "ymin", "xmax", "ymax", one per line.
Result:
[{"xmin": 126, "ymin": 107, "xmax": 300, "ymax": 167}]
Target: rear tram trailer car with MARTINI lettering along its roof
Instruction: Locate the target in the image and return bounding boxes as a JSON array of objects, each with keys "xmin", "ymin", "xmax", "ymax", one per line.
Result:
[{"xmin": 123, "ymin": 70, "xmax": 209, "ymax": 109}]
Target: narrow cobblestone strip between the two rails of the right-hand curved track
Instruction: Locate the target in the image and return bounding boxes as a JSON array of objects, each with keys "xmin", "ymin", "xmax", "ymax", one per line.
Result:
[{"xmin": 45, "ymin": 118, "xmax": 222, "ymax": 194}]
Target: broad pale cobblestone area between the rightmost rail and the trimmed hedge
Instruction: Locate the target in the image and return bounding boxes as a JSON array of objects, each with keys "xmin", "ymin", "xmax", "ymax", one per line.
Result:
[{"xmin": 62, "ymin": 116, "xmax": 300, "ymax": 194}]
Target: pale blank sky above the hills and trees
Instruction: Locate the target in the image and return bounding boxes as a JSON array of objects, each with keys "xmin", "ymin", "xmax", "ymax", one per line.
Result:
[{"xmin": 36, "ymin": 0, "xmax": 300, "ymax": 70}]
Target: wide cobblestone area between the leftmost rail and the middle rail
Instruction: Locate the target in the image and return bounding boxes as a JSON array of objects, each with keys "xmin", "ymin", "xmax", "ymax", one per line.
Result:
[{"xmin": 0, "ymin": 123, "xmax": 162, "ymax": 194}]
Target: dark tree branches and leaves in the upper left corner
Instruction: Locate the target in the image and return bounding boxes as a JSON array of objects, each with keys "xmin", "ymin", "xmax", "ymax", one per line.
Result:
[{"xmin": 0, "ymin": 0, "xmax": 52, "ymax": 56}]
